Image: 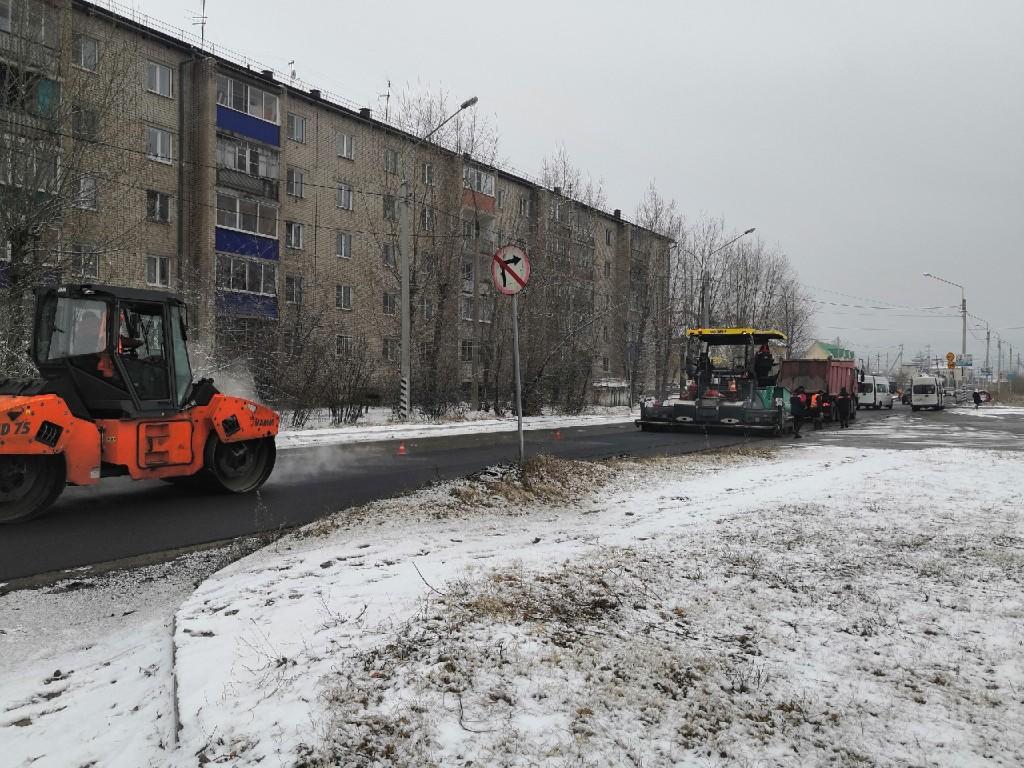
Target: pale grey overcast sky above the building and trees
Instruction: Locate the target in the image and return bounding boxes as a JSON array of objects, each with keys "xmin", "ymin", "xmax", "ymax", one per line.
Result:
[{"xmin": 136, "ymin": 0, "xmax": 1024, "ymax": 367}]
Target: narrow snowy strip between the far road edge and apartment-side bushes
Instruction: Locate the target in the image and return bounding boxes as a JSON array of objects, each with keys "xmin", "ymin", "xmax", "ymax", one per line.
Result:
[{"xmin": 278, "ymin": 407, "xmax": 640, "ymax": 450}]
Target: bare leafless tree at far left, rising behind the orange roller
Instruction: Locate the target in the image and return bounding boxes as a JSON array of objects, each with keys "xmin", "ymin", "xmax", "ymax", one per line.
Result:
[{"xmin": 0, "ymin": 0, "xmax": 143, "ymax": 373}]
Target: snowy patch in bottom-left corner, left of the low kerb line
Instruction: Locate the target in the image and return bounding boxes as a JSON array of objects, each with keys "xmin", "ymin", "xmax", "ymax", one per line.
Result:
[{"xmin": 0, "ymin": 551, "xmax": 230, "ymax": 768}]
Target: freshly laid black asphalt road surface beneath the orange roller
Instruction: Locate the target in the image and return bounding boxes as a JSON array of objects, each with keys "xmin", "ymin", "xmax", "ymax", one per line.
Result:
[{"xmin": 0, "ymin": 414, "xmax": 913, "ymax": 581}]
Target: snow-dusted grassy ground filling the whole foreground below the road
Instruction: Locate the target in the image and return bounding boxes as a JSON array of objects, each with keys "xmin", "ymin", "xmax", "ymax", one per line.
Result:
[{"xmin": 0, "ymin": 419, "xmax": 1024, "ymax": 768}]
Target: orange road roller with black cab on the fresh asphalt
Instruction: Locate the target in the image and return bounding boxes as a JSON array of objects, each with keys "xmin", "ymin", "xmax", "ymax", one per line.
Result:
[{"xmin": 0, "ymin": 286, "xmax": 279, "ymax": 522}]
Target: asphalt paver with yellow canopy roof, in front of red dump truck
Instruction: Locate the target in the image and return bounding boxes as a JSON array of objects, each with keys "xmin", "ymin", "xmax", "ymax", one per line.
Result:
[{"xmin": 635, "ymin": 328, "xmax": 793, "ymax": 435}]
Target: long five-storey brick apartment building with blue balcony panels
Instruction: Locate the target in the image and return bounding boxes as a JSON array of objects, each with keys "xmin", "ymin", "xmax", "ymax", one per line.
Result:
[{"xmin": 0, "ymin": 0, "xmax": 670, "ymax": 402}]
